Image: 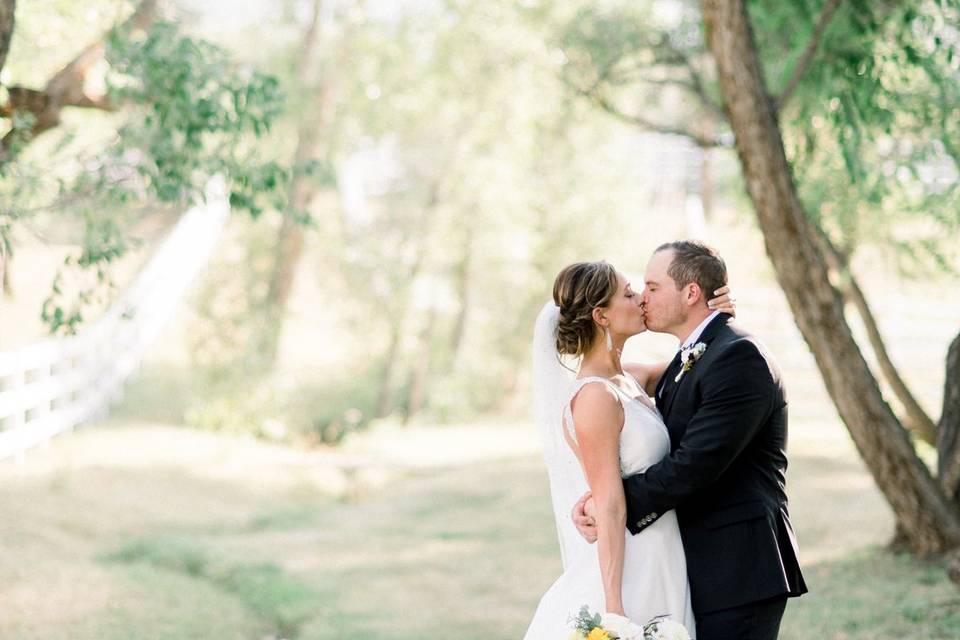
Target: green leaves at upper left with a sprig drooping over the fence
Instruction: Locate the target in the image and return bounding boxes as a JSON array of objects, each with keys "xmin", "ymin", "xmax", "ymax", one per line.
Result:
[{"xmin": 27, "ymin": 22, "xmax": 291, "ymax": 333}]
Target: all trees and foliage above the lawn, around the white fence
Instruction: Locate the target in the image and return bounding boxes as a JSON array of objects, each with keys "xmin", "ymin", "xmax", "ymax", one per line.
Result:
[{"xmin": 0, "ymin": 0, "xmax": 960, "ymax": 551}]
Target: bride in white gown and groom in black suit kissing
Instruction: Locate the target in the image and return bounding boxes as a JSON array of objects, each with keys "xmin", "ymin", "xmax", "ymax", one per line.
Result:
[{"xmin": 524, "ymin": 241, "xmax": 807, "ymax": 640}]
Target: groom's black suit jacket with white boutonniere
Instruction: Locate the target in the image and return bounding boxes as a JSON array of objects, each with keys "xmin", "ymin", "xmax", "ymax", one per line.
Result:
[{"xmin": 624, "ymin": 314, "xmax": 807, "ymax": 615}]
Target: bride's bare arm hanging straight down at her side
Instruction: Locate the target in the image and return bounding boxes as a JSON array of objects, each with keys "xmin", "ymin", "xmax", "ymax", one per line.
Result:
[{"xmin": 573, "ymin": 383, "xmax": 627, "ymax": 615}]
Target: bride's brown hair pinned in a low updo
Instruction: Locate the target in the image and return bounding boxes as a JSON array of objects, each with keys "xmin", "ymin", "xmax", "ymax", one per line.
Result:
[{"xmin": 553, "ymin": 261, "xmax": 617, "ymax": 357}]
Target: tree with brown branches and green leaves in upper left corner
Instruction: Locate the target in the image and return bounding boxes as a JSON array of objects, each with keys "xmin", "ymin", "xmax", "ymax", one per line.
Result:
[{"xmin": 0, "ymin": 0, "xmax": 286, "ymax": 333}]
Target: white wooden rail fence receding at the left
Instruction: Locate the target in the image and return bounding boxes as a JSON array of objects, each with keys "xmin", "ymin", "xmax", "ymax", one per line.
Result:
[{"xmin": 0, "ymin": 179, "xmax": 230, "ymax": 460}]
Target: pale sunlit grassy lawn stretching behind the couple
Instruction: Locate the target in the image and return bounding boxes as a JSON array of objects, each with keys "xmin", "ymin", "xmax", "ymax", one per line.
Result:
[{"xmin": 0, "ymin": 423, "xmax": 960, "ymax": 640}]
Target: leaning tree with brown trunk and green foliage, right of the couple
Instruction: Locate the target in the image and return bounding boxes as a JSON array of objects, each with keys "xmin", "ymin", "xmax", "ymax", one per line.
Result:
[{"xmin": 564, "ymin": 1, "xmax": 960, "ymax": 552}]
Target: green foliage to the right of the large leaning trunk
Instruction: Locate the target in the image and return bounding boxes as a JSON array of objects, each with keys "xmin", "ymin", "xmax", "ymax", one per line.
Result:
[{"xmin": 751, "ymin": 0, "xmax": 960, "ymax": 273}]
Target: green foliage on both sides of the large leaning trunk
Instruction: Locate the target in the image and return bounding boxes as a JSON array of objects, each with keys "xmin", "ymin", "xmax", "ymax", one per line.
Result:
[{"xmin": 557, "ymin": 0, "xmax": 960, "ymax": 276}]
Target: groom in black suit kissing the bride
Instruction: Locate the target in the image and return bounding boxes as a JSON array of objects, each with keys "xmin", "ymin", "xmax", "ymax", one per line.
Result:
[{"xmin": 573, "ymin": 241, "xmax": 807, "ymax": 640}]
